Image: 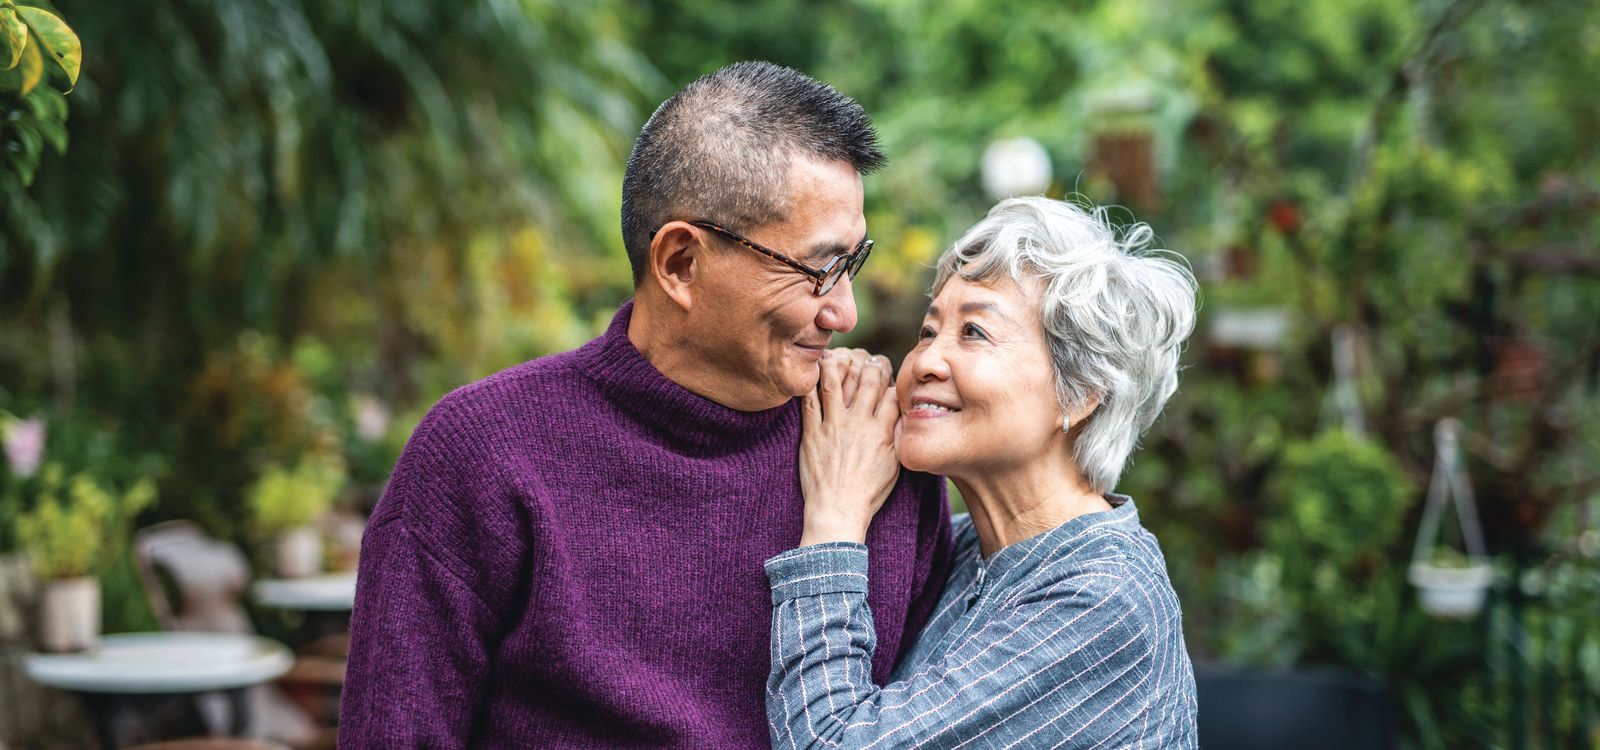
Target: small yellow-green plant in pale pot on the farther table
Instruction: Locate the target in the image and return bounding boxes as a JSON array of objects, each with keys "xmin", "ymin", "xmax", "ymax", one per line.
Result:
[{"xmin": 250, "ymin": 457, "xmax": 346, "ymax": 579}]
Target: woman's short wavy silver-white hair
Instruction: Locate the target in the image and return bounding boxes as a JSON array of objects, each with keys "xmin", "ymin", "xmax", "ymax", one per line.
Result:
[{"xmin": 933, "ymin": 197, "xmax": 1198, "ymax": 493}]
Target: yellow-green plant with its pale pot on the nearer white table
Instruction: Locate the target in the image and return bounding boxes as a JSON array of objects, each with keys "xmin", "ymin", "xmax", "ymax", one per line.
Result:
[{"xmin": 16, "ymin": 465, "xmax": 155, "ymax": 651}]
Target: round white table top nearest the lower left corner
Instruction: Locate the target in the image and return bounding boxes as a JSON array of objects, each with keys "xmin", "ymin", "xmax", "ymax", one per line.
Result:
[{"xmin": 26, "ymin": 632, "xmax": 294, "ymax": 694}]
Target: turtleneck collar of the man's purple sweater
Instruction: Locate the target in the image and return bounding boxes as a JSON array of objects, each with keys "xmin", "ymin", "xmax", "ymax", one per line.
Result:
[{"xmin": 574, "ymin": 299, "xmax": 800, "ymax": 456}]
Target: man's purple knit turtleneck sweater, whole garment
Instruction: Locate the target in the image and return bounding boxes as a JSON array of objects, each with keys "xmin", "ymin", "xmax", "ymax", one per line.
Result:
[{"xmin": 339, "ymin": 302, "xmax": 950, "ymax": 748}]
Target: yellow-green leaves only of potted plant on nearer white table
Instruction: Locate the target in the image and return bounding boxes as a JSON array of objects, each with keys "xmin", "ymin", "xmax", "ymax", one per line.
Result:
[{"xmin": 16, "ymin": 465, "xmax": 155, "ymax": 579}]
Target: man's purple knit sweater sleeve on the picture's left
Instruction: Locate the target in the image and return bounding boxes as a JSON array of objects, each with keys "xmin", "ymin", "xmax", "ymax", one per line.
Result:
[{"xmin": 339, "ymin": 390, "xmax": 528, "ymax": 748}]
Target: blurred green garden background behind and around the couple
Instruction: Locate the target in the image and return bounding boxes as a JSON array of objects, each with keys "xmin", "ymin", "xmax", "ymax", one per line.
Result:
[{"xmin": 0, "ymin": 0, "xmax": 1600, "ymax": 748}]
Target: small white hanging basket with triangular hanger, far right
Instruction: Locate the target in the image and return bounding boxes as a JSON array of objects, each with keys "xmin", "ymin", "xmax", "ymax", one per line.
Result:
[{"xmin": 1406, "ymin": 419, "xmax": 1494, "ymax": 619}]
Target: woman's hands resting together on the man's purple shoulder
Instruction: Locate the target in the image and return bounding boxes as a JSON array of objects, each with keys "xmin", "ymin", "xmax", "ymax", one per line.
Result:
[{"xmin": 800, "ymin": 352, "xmax": 899, "ymax": 545}]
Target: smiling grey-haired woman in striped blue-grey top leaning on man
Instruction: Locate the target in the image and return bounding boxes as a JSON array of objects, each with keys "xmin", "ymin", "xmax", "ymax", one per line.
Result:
[{"xmin": 766, "ymin": 198, "xmax": 1197, "ymax": 748}]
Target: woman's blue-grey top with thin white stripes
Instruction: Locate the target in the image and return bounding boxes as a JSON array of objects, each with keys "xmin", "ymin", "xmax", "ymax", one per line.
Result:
[{"xmin": 766, "ymin": 494, "xmax": 1197, "ymax": 750}]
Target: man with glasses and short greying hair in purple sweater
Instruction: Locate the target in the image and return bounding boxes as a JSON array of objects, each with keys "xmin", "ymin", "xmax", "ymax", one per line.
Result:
[{"xmin": 339, "ymin": 62, "xmax": 950, "ymax": 748}]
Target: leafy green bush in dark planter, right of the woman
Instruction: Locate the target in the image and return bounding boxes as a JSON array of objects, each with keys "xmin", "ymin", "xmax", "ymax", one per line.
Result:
[{"xmin": 1194, "ymin": 428, "xmax": 1411, "ymax": 747}]
